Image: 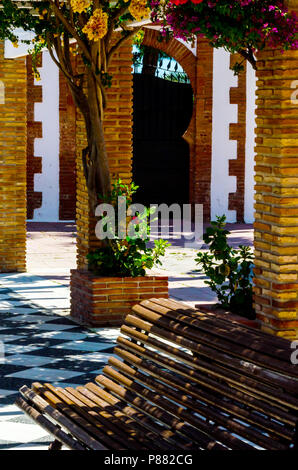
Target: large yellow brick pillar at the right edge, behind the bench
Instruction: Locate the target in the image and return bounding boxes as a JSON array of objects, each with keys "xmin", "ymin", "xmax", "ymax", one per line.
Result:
[{"xmin": 255, "ymin": 0, "xmax": 298, "ymax": 338}]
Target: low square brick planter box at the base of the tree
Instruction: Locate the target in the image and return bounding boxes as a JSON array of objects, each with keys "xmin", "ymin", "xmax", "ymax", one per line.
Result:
[{"xmin": 70, "ymin": 269, "xmax": 169, "ymax": 326}]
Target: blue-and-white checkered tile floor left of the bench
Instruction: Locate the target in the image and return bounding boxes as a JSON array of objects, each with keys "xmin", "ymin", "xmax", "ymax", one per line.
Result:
[{"xmin": 0, "ymin": 287, "xmax": 119, "ymax": 450}]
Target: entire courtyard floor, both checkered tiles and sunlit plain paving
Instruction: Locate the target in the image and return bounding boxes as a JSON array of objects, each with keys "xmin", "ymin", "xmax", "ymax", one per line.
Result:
[{"xmin": 0, "ymin": 223, "xmax": 253, "ymax": 450}]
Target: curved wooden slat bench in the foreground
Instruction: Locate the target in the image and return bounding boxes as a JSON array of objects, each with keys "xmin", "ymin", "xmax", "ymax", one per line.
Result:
[{"xmin": 16, "ymin": 299, "xmax": 298, "ymax": 451}]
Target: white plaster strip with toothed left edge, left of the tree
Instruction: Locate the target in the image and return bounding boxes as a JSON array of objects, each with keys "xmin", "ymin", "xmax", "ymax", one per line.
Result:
[{"xmin": 33, "ymin": 52, "xmax": 59, "ymax": 222}]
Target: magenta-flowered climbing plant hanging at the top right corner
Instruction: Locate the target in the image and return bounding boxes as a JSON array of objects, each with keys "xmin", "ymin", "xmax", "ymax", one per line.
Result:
[{"xmin": 150, "ymin": 0, "xmax": 298, "ymax": 72}]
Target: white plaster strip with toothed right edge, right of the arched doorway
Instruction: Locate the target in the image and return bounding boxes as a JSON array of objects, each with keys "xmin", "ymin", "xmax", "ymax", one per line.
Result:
[{"xmin": 211, "ymin": 49, "xmax": 238, "ymax": 223}]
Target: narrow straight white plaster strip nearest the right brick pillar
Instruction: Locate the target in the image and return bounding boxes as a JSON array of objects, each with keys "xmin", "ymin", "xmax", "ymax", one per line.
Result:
[{"xmin": 244, "ymin": 63, "xmax": 257, "ymax": 224}]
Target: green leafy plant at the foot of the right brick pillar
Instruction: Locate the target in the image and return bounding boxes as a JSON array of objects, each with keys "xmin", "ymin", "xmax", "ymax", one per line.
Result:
[{"xmin": 195, "ymin": 216, "xmax": 255, "ymax": 319}]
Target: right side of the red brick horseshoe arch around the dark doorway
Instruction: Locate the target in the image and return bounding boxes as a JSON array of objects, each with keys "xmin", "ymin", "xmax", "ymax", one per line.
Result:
[{"xmin": 143, "ymin": 28, "xmax": 213, "ymax": 221}]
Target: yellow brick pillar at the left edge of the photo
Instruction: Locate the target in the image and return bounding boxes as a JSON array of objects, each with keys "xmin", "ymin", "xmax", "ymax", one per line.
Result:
[{"xmin": 0, "ymin": 42, "xmax": 27, "ymax": 273}]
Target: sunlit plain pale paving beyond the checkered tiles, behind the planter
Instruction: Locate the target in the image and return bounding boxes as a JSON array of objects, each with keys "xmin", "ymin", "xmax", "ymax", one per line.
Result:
[{"xmin": 26, "ymin": 222, "xmax": 253, "ymax": 308}]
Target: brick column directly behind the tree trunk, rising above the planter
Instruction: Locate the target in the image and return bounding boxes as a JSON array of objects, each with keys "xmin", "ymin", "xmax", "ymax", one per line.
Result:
[{"xmin": 77, "ymin": 43, "xmax": 133, "ymax": 269}]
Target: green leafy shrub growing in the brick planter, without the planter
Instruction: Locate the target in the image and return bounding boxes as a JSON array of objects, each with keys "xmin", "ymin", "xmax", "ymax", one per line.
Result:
[{"xmin": 87, "ymin": 179, "xmax": 170, "ymax": 277}]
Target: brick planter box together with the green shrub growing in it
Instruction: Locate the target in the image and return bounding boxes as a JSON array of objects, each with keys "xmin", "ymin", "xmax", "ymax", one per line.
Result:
[{"xmin": 71, "ymin": 180, "xmax": 170, "ymax": 326}]
